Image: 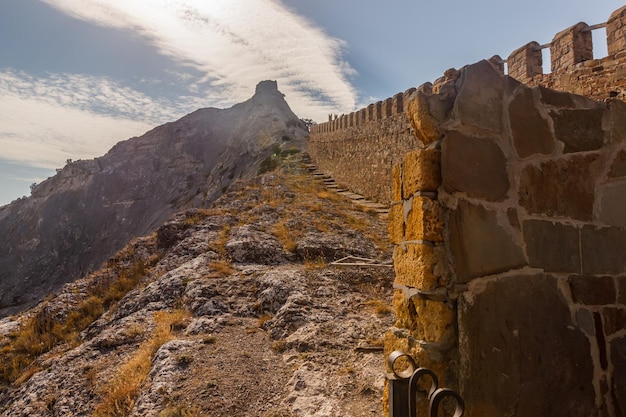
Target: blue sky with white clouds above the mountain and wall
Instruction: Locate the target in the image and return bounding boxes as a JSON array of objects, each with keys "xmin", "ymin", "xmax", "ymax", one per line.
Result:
[{"xmin": 0, "ymin": 0, "xmax": 624, "ymax": 205}]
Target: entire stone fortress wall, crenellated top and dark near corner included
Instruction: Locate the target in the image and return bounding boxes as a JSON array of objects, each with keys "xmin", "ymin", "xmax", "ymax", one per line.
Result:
[{"xmin": 309, "ymin": 6, "xmax": 626, "ymax": 417}]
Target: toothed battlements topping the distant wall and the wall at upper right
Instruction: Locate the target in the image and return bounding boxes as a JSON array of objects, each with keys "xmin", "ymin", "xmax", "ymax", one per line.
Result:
[{"xmin": 311, "ymin": 6, "xmax": 626, "ymax": 134}]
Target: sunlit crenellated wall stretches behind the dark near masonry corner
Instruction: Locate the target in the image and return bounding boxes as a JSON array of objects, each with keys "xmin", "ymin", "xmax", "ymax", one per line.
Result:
[{"xmin": 308, "ymin": 6, "xmax": 626, "ymax": 203}]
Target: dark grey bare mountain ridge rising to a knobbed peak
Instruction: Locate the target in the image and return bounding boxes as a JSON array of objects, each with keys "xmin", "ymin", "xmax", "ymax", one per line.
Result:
[{"xmin": 0, "ymin": 81, "xmax": 307, "ymax": 317}]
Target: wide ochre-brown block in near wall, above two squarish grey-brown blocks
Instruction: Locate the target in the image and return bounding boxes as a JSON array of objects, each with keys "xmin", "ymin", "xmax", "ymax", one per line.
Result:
[{"xmin": 519, "ymin": 154, "xmax": 602, "ymax": 221}]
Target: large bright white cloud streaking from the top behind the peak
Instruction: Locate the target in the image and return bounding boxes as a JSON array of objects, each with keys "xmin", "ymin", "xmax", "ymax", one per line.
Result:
[{"xmin": 44, "ymin": 0, "xmax": 356, "ymax": 120}]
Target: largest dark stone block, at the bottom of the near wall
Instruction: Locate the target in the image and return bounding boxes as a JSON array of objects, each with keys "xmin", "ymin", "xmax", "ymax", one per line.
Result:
[{"xmin": 459, "ymin": 274, "xmax": 595, "ymax": 417}]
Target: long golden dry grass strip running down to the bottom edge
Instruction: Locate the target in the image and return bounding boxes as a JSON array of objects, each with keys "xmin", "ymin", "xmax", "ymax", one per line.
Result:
[{"xmin": 93, "ymin": 310, "xmax": 189, "ymax": 417}]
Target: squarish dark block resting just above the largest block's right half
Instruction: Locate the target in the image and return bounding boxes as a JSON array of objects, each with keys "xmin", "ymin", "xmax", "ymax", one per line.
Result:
[{"xmin": 523, "ymin": 220, "xmax": 581, "ymax": 273}]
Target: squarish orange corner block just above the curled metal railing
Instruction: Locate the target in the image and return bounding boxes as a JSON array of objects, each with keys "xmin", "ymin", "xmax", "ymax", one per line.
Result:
[{"xmin": 413, "ymin": 298, "xmax": 456, "ymax": 344}]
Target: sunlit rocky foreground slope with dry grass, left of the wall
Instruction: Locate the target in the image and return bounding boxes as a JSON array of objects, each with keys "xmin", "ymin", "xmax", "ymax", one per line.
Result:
[{"xmin": 0, "ymin": 155, "xmax": 394, "ymax": 417}]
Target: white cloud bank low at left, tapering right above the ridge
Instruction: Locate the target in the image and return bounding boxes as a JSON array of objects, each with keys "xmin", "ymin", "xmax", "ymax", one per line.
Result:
[{"xmin": 0, "ymin": 71, "xmax": 161, "ymax": 168}]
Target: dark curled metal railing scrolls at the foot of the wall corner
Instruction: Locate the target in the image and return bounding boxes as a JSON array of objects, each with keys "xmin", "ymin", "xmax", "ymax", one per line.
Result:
[{"xmin": 385, "ymin": 350, "xmax": 465, "ymax": 417}]
